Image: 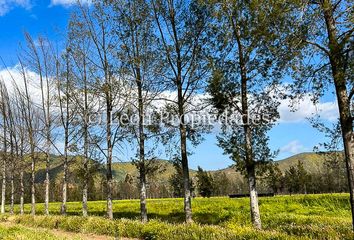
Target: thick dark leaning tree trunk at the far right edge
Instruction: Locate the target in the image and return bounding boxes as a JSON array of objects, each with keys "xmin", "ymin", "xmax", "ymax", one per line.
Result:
[{"xmin": 322, "ymin": 0, "xmax": 354, "ymax": 230}]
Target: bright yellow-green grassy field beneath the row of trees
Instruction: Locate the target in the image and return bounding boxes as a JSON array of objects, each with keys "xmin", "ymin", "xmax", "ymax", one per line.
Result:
[{"xmin": 0, "ymin": 194, "xmax": 354, "ymax": 239}]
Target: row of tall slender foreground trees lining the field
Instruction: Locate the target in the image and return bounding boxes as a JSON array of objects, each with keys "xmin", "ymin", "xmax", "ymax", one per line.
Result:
[{"xmin": 0, "ymin": 0, "xmax": 354, "ymax": 229}]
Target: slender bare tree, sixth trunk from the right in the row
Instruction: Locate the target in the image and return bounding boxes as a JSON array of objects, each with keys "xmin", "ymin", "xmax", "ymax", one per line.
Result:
[{"xmin": 68, "ymin": 9, "xmax": 99, "ymax": 217}]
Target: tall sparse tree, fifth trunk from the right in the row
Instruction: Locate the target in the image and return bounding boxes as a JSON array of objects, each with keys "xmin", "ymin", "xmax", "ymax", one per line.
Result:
[{"xmin": 75, "ymin": 1, "xmax": 129, "ymax": 219}]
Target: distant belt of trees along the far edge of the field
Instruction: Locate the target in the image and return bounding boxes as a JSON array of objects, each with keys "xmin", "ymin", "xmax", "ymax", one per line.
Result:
[{"xmin": 1, "ymin": 156, "xmax": 348, "ymax": 204}]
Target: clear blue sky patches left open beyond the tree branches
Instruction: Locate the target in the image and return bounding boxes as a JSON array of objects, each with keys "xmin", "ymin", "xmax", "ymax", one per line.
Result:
[{"xmin": 0, "ymin": 0, "xmax": 337, "ymax": 170}]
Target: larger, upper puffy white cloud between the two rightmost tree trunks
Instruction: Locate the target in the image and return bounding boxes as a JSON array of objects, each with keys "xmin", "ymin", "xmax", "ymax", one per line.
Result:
[{"xmin": 279, "ymin": 96, "xmax": 338, "ymax": 123}]
